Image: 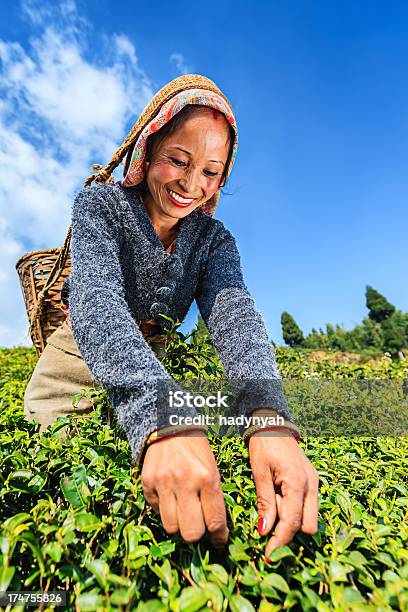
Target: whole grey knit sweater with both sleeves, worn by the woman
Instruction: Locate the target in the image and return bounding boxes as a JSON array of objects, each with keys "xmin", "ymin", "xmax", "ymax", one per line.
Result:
[{"xmin": 64, "ymin": 184, "xmax": 292, "ymax": 458}]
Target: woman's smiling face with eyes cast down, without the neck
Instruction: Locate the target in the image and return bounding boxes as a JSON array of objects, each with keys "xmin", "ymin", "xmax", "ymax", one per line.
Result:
[{"xmin": 145, "ymin": 108, "xmax": 230, "ymax": 221}]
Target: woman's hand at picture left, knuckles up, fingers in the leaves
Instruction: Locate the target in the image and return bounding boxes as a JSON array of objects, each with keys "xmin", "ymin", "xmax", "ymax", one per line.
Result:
[{"xmin": 141, "ymin": 431, "xmax": 229, "ymax": 548}]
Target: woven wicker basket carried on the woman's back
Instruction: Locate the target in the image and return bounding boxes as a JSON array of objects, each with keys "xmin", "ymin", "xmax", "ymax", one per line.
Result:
[{"xmin": 16, "ymin": 237, "xmax": 71, "ymax": 357}]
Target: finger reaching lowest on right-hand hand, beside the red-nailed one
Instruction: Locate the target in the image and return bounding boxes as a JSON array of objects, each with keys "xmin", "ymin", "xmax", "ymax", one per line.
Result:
[{"xmin": 265, "ymin": 481, "xmax": 306, "ymax": 556}]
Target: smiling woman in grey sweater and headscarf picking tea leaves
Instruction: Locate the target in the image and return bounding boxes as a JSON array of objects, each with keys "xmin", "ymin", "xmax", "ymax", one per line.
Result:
[{"xmin": 26, "ymin": 75, "xmax": 318, "ymax": 555}]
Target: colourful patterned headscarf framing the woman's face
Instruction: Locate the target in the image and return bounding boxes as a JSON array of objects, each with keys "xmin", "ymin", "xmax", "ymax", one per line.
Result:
[{"xmin": 120, "ymin": 88, "xmax": 238, "ymax": 217}]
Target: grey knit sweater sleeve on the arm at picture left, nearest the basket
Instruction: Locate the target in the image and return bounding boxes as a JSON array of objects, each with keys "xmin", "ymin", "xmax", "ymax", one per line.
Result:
[{"xmin": 69, "ymin": 185, "xmax": 195, "ymax": 459}]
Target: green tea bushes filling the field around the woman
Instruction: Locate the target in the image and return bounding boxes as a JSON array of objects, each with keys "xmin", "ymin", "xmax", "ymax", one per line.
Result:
[{"xmin": 0, "ymin": 334, "xmax": 408, "ymax": 612}]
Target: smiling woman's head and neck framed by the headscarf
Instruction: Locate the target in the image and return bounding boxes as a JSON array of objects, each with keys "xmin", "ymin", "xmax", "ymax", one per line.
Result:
[{"xmin": 121, "ymin": 105, "xmax": 235, "ymax": 245}]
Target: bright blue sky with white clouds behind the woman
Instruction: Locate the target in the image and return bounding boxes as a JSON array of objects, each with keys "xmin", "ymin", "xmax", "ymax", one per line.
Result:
[{"xmin": 0, "ymin": 0, "xmax": 408, "ymax": 346}]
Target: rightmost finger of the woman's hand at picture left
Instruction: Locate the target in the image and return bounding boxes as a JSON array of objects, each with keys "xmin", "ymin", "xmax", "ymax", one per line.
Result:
[{"xmin": 200, "ymin": 480, "xmax": 229, "ymax": 548}]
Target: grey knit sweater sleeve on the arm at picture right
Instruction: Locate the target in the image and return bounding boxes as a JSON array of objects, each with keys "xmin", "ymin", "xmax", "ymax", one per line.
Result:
[{"xmin": 196, "ymin": 224, "xmax": 292, "ymax": 421}]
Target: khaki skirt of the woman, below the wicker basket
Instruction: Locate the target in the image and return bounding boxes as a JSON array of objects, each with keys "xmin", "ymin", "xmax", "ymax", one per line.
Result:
[{"xmin": 24, "ymin": 319, "xmax": 163, "ymax": 433}]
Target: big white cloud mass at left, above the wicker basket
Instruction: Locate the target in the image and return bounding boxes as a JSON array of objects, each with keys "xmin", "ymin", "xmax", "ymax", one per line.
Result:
[{"xmin": 0, "ymin": 0, "xmax": 153, "ymax": 346}]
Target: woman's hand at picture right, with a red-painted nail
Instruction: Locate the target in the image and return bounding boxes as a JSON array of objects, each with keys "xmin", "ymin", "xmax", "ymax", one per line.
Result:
[{"xmin": 248, "ymin": 411, "xmax": 319, "ymax": 558}]
